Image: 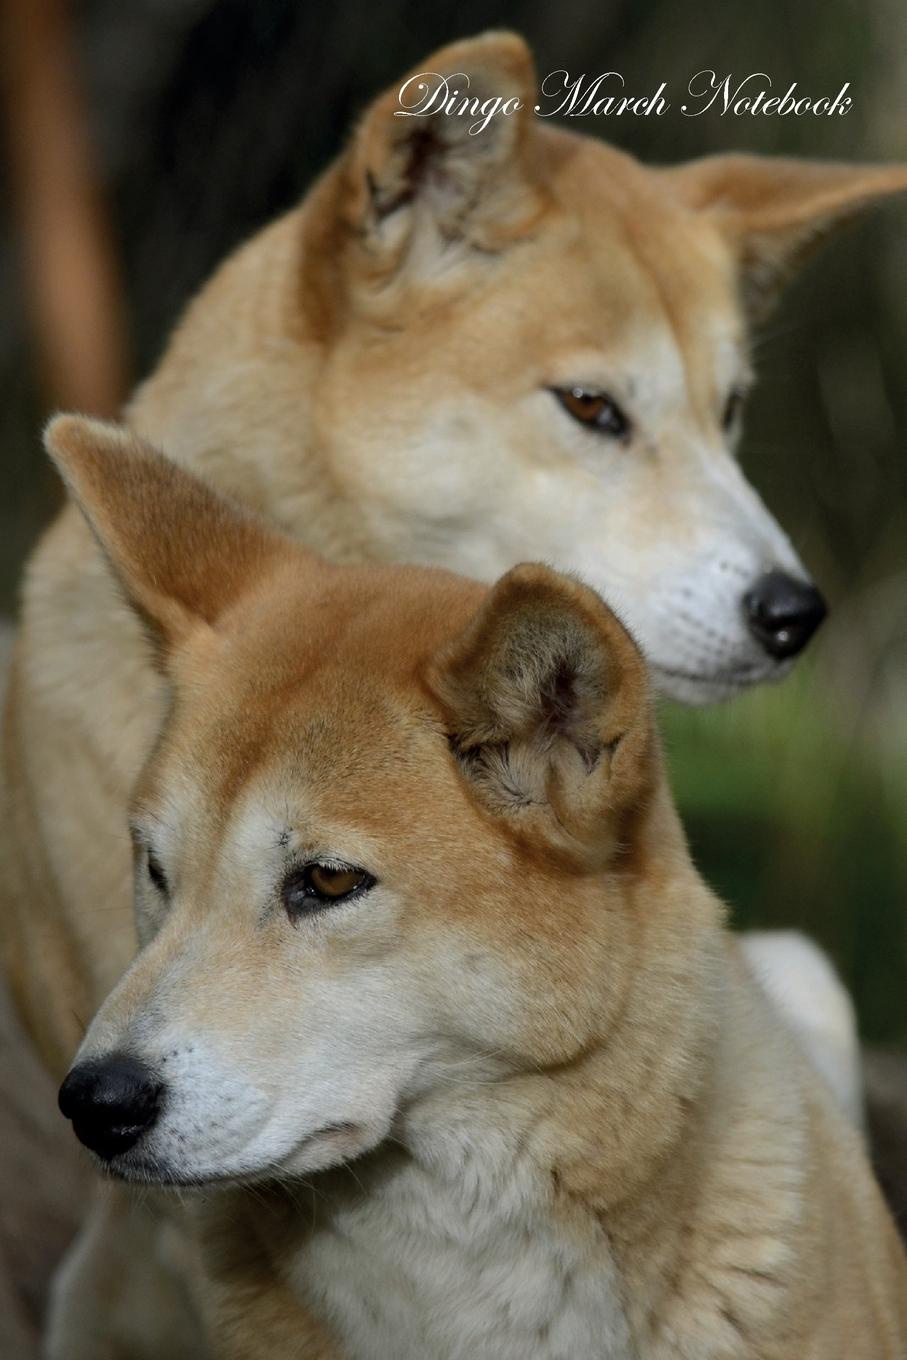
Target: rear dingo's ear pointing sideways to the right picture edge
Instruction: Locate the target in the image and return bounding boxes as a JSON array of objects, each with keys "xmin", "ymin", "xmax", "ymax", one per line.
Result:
[{"xmin": 665, "ymin": 155, "xmax": 907, "ymax": 321}]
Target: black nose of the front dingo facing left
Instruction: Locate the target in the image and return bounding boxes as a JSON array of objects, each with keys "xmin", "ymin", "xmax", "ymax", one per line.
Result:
[{"xmin": 60, "ymin": 1053, "xmax": 163, "ymax": 1161}]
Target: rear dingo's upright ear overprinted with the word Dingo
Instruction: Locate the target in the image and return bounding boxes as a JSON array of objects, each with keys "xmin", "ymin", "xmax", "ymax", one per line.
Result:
[{"xmin": 344, "ymin": 33, "xmax": 541, "ymax": 267}]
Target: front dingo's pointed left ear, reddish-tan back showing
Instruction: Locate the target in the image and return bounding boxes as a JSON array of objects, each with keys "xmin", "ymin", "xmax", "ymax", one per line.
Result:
[{"xmin": 45, "ymin": 415, "xmax": 294, "ymax": 646}]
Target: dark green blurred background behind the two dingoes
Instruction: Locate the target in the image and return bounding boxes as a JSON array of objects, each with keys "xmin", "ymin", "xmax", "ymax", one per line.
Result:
[{"xmin": 0, "ymin": 0, "xmax": 907, "ymax": 1042}]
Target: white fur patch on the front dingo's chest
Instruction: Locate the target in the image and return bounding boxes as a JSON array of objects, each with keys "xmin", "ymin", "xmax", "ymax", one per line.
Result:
[{"xmin": 294, "ymin": 1147, "xmax": 635, "ymax": 1360}]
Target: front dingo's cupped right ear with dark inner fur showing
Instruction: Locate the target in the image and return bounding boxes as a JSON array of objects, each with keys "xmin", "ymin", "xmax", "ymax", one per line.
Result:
[{"xmin": 430, "ymin": 564, "xmax": 657, "ymax": 861}]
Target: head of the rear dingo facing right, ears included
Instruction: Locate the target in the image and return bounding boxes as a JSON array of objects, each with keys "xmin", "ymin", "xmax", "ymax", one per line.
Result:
[{"xmin": 261, "ymin": 34, "xmax": 907, "ymax": 702}]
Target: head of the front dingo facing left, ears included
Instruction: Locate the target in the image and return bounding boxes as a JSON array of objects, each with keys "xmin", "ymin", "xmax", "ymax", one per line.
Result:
[{"xmin": 49, "ymin": 418, "xmax": 691, "ymax": 1183}]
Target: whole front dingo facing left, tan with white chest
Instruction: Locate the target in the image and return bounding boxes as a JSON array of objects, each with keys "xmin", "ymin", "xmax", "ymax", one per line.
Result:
[{"xmin": 49, "ymin": 418, "xmax": 907, "ymax": 1360}]
